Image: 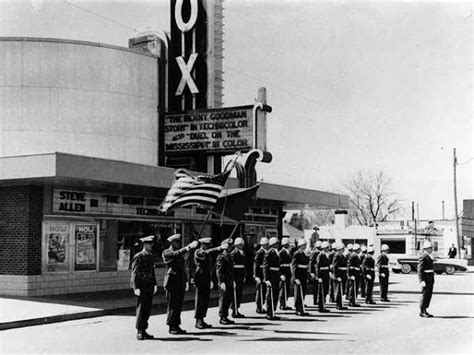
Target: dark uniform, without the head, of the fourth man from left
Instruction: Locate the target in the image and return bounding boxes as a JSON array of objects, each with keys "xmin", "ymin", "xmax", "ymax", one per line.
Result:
[{"xmin": 216, "ymin": 250, "xmax": 234, "ymax": 318}]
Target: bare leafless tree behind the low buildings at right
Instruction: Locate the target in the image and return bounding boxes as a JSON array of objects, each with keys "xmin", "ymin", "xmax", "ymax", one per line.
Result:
[{"xmin": 345, "ymin": 170, "xmax": 402, "ymax": 226}]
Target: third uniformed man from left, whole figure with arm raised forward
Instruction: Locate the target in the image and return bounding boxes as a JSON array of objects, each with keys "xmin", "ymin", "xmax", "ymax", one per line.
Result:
[{"xmin": 194, "ymin": 238, "xmax": 221, "ymax": 329}]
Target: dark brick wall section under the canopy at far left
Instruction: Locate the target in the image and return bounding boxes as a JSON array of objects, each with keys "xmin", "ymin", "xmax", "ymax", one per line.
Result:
[{"xmin": 0, "ymin": 186, "xmax": 43, "ymax": 275}]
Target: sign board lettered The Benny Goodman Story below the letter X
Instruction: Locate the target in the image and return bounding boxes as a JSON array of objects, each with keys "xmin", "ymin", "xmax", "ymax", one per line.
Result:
[{"xmin": 164, "ymin": 105, "xmax": 254, "ymax": 153}]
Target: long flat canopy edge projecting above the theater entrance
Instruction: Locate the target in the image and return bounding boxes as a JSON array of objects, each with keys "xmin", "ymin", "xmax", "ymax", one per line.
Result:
[{"xmin": 0, "ymin": 152, "xmax": 349, "ymax": 208}]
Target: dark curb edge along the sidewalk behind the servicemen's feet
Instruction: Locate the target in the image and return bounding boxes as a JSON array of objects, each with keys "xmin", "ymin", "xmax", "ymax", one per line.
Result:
[{"xmin": 0, "ymin": 292, "xmax": 255, "ymax": 331}]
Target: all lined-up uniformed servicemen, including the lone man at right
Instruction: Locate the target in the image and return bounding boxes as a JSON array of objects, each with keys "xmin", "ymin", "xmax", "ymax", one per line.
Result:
[{"xmin": 131, "ymin": 234, "xmax": 434, "ymax": 340}]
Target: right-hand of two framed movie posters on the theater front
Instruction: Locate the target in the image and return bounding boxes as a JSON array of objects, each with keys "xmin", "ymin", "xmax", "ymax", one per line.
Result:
[{"xmin": 74, "ymin": 224, "xmax": 97, "ymax": 270}]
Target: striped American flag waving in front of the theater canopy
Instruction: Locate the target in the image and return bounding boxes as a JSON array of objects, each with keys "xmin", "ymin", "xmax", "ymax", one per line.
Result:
[{"xmin": 160, "ymin": 169, "xmax": 231, "ymax": 212}]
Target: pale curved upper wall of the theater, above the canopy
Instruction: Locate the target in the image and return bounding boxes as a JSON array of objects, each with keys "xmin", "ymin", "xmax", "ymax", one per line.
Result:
[{"xmin": 0, "ymin": 38, "xmax": 158, "ymax": 165}]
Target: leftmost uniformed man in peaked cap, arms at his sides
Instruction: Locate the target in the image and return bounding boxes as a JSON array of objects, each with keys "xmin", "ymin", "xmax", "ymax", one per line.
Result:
[{"xmin": 130, "ymin": 235, "xmax": 158, "ymax": 340}]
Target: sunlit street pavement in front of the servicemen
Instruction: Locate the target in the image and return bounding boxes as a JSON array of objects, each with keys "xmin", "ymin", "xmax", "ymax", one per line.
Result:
[{"xmin": 0, "ymin": 273, "xmax": 474, "ymax": 354}]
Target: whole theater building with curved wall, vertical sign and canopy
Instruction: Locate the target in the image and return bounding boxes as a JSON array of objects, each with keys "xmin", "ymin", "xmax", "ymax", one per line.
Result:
[{"xmin": 0, "ymin": 0, "xmax": 348, "ymax": 296}]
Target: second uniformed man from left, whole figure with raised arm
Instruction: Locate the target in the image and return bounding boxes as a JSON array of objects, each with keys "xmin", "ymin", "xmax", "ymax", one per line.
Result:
[{"xmin": 163, "ymin": 234, "xmax": 198, "ymax": 335}]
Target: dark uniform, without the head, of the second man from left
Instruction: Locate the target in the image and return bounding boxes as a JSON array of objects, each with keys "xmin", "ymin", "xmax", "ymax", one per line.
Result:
[{"xmin": 163, "ymin": 248, "xmax": 187, "ymax": 327}]
